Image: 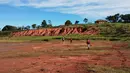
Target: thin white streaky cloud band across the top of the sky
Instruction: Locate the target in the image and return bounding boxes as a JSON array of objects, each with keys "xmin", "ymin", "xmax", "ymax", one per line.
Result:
[{"xmin": 0, "ymin": 0, "xmax": 130, "ymax": 18}]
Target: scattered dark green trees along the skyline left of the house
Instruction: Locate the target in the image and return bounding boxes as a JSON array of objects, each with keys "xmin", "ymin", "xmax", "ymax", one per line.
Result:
[{"xmin": 2, "ymin": 18, "xmax": 88, "ymax": 31}]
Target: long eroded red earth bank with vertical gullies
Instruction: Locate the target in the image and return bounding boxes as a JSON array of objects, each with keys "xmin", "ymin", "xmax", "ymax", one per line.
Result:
[{"xmin": 12, "ymin": 27, "xmax": 99, "ymax": 36}]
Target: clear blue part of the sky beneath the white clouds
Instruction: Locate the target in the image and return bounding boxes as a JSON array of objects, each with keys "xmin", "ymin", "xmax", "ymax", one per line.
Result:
[{"xmin": 0, "ymin": 5, "xmax": 83, "ymax": 27}]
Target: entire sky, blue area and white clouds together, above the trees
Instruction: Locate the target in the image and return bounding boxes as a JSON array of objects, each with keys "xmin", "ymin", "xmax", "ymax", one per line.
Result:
[{"xmin": 0, "ymin": 0, "xmax": 130, "ymax": 28}]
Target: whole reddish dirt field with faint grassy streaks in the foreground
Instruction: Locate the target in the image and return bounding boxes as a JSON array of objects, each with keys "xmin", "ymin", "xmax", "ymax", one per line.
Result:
[{"xmin": 0, "ymin": 40, "xmax": 130, "ymax": 73}]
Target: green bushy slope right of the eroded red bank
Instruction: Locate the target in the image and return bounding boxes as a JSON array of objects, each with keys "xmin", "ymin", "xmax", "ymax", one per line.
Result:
[{"xmin": 98, "ymin": 23, "xmax": 130, "ymax": 37}]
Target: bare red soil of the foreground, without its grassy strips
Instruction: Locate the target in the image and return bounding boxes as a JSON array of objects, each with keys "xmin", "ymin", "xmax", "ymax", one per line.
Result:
[{"xmin": 0, "ymin": 41, "xmax": 130, "ymax": 73}]
